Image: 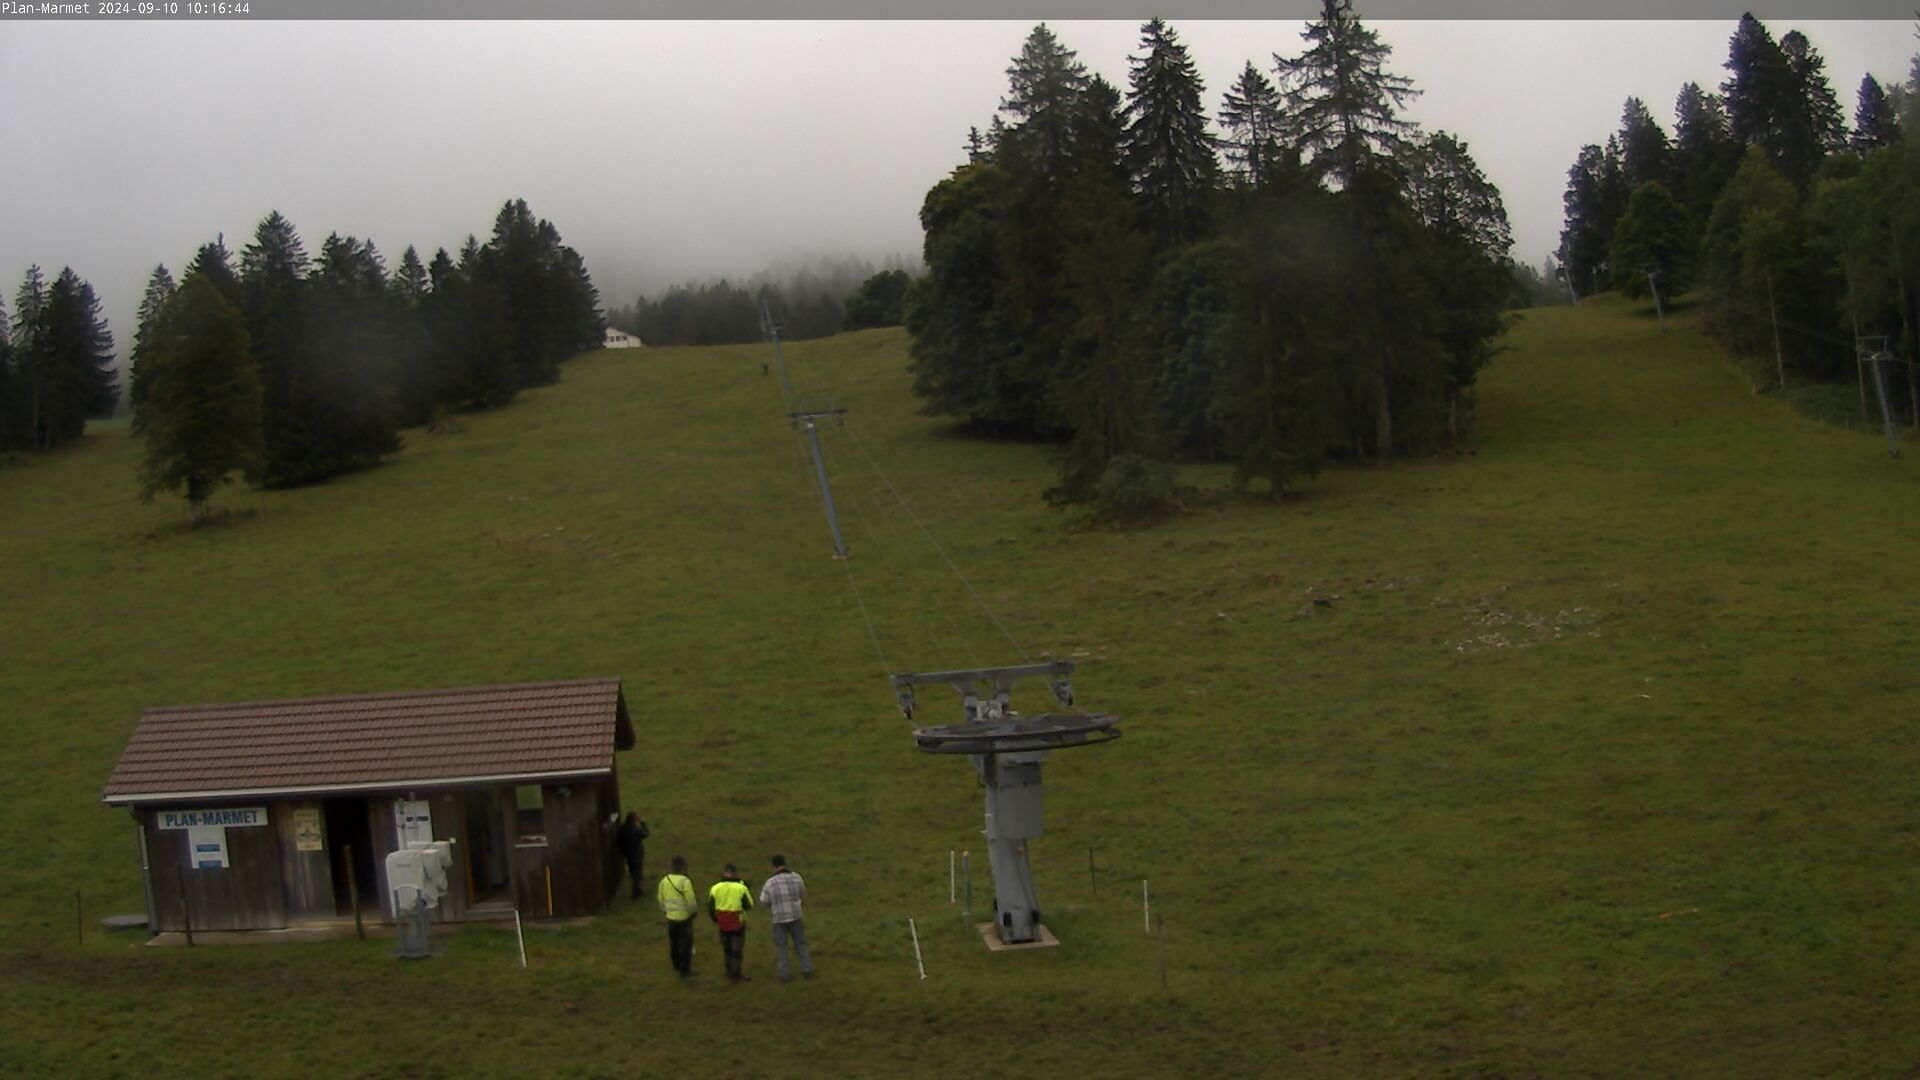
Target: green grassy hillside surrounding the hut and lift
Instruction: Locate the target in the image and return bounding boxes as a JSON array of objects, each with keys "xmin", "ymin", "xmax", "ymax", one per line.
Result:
[{"xmin": 0, "ymin": 295, "xmax": 1920, "ymax": 1080}]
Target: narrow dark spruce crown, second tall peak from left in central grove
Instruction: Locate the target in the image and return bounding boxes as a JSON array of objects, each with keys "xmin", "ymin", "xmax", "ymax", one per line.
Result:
[{"xmin": 1125, "ymin": 19, "xmax": 1219, "ymax": 248}]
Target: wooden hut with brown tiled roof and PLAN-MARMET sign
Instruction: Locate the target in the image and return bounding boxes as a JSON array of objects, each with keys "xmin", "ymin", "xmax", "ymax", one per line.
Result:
[{"xmin": 100, "ymin": 678, "xmax": 634, "ymax": 930}]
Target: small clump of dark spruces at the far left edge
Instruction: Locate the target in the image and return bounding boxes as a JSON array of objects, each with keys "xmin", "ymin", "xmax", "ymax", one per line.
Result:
[{"xmin": 0, "ymin": 265, "xmax": 119, "ymax": 452}]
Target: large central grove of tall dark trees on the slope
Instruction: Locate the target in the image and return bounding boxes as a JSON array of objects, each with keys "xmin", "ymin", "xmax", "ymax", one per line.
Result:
[{"xmin": 906, "ymin": 0, "xmax": 1515, "ymax": 513}]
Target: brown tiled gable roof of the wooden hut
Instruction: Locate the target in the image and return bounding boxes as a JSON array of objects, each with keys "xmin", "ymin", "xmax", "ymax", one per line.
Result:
[{"xmin": 100, "ymin": 678, "xmax": 634, "ymax": 803}]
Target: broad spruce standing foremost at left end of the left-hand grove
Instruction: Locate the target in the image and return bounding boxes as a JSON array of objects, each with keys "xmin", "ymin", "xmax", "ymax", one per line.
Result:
[{"xmin": 134, "ymin": 273, "xmax": 267, "ymax": 525}]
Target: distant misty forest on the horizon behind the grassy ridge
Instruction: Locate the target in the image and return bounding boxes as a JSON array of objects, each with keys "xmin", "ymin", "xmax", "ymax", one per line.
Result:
[{"xmin": 607, "ymin": 259, "xmax": 908, "ymax": 346}]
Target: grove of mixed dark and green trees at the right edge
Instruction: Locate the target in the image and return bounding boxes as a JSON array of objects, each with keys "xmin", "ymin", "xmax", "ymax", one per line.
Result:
[{"xmin": 1559, "ymin": 13, "xmax": 1920, "ymax": 411}]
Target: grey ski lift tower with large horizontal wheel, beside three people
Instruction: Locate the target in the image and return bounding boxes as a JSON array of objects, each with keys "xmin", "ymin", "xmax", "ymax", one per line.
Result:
[{"xmin": 893, "ymin": 659, "xmax": 1119, "ymax": 945}]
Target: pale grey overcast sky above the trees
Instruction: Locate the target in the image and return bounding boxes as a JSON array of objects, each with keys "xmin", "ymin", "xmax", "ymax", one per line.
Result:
[{"xmin": 0, "ymin": 19, "xmax": 1920, "ymax": 350}]
